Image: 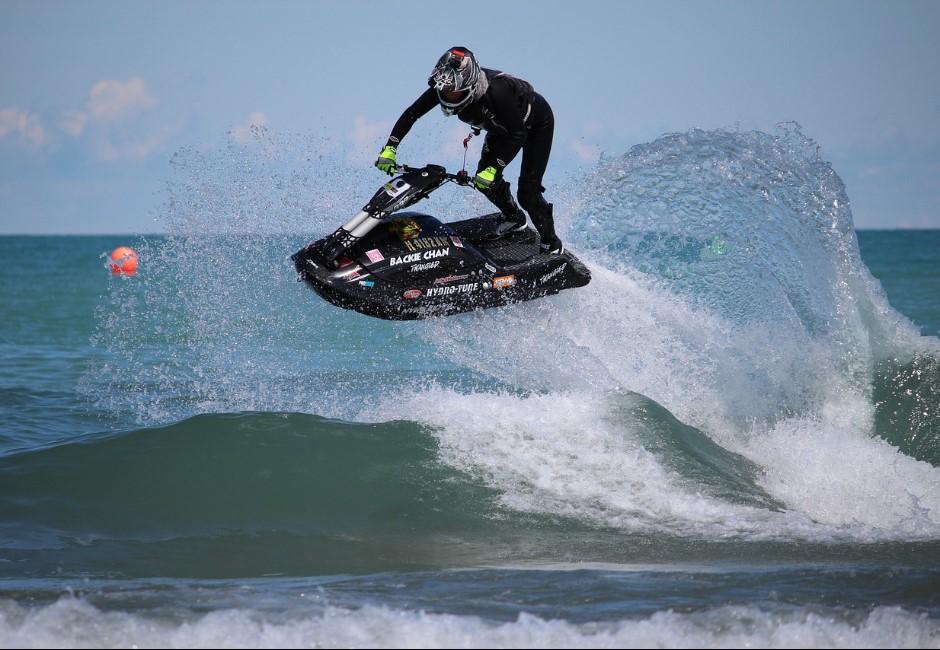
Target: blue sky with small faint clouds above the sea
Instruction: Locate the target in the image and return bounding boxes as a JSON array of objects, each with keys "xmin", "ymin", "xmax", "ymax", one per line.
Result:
[{"xmin": 0, "ymin": 0, "xmax": 940, "ymax": 234}]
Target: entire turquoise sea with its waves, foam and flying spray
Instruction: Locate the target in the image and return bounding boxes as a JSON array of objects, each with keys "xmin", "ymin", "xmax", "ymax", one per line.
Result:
[{"xmin": 0, "ymin": 126, "xmax": 940, "ymax": 647}]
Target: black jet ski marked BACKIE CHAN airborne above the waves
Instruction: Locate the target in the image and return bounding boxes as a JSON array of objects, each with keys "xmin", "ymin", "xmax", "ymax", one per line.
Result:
[{"xmin": 291, "ymin": 165, "xmax": 591, "ymax": 320}]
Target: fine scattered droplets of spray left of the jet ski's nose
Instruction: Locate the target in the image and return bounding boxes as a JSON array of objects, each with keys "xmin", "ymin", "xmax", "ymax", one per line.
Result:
[{"xmin": 80, "ymin": 129, "xmax": 492, "ymax": 424}]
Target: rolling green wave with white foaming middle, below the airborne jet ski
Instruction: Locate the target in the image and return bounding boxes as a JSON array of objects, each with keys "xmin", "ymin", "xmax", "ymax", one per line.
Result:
[{"xmin": 7, "ymin": 404, "xmax": 933, "ymax": 577}]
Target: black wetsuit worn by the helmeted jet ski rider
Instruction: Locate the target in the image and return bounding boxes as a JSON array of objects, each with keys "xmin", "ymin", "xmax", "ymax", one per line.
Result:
[{"xmin": 387, "ymin": 68, "xmax": 558, "ymax": 244}]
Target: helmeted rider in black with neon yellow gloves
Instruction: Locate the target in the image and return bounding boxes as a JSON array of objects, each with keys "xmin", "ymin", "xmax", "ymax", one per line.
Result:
[{"xmin": 375, "ymin": 47, "xmax": 564, "ymax": 253}]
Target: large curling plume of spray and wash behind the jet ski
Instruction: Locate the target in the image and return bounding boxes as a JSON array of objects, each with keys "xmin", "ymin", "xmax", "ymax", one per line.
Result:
[{"xmin": 412, "ymin": 127, "xmax": 940, "ymax": 537}]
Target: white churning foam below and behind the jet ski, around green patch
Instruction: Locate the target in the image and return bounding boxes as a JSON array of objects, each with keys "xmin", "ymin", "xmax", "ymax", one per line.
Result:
[{"xmin": 361, "ymin": 251, "xmax": 940, "ymax": 541}]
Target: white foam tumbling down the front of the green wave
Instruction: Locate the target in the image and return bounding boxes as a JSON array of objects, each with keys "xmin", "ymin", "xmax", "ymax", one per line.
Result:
[{"xmin": 371, "ymin": 389, "xmax": 780, "ymax": 534}]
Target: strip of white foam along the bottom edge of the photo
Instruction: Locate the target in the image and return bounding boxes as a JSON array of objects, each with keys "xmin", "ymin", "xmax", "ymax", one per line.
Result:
[{"xmin": 0, "ymin": 598, "xmax": 940, "ymax": 648}]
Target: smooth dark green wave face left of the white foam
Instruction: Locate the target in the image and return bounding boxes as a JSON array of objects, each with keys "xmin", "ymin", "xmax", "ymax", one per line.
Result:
[{"xmin": 0, "ymin": 413, "xmax": 511, "ymax": 575}]
